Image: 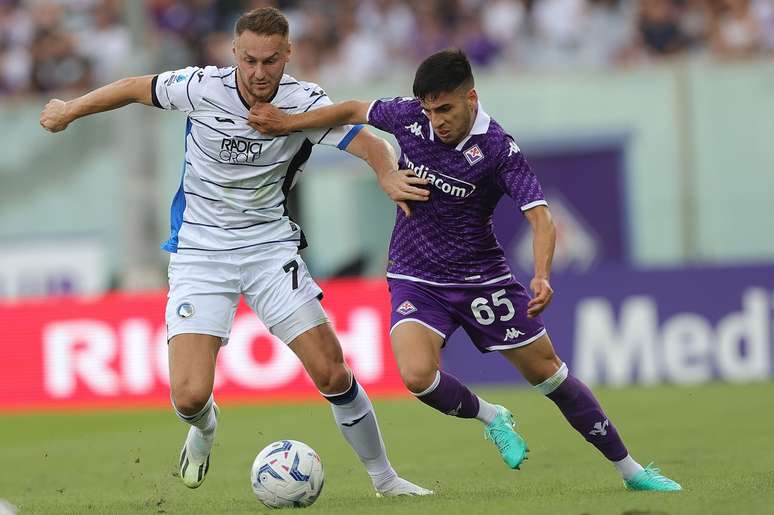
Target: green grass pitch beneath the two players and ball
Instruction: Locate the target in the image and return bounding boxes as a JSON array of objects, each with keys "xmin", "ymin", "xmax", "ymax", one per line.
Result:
[{"xmin": 0, "ymin": 383, "xmax": 774, "ymax": 515}]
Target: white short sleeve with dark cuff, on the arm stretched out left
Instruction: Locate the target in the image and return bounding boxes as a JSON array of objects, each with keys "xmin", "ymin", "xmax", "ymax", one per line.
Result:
[{"xmin": 151, "ymin": 66, "xmax": 207, "ymax": 113}]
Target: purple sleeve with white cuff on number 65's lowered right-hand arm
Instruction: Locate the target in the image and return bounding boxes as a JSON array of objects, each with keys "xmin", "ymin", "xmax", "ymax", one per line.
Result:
[{"xmin": 497, "ymin": 137, "xmax": 548, "ymax": 211}]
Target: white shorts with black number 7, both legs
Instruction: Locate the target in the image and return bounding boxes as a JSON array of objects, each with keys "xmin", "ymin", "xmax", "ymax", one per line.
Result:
[{"xmin": 166, "ymin": 243, "xmax": 322, "ymax": 345}]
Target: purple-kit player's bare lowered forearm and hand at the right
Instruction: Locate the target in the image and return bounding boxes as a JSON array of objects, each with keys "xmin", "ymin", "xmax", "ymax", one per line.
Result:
[{"xmin": 524, "ymin": 206, "xmax": 556, "ymax": 318}]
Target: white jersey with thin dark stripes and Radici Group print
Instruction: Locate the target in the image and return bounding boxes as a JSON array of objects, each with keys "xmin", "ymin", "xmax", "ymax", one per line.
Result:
[{"xmin": 151, "ymin": 66, "xmax": 362, "ymax": 253}]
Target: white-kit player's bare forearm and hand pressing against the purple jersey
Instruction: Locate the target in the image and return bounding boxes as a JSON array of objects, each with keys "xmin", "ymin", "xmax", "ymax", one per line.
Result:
[{"xmin": 346, "ymin": 129, "xmax": 430, "ymax": 216}]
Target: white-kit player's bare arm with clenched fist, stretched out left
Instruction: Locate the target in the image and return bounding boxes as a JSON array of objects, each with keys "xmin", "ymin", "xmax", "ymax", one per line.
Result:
[{"xmin": 40, "ymin": 75, "xmax": 153, "ymax": 132}]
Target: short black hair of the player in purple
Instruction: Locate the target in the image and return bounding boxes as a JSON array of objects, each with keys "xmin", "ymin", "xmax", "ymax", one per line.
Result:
[{"xmin": 414, "ymin": 48, "xmax": 475, "ymax": 100}]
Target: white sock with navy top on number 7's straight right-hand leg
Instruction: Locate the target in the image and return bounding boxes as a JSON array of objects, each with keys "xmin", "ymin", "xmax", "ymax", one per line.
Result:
[{"xmin": 325, "ymin": 378, "xmax": 397, "ymax": 489}]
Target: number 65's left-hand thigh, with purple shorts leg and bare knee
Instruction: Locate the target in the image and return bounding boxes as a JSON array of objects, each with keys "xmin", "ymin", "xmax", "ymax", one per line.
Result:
[{"xmin": 387, "ymin": 279, "xmax": 458, "ymax": 392}]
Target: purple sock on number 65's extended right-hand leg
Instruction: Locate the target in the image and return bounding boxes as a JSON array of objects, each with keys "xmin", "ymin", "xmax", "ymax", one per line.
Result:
[{"xmin": 546, "ymin": 374, "xmax": 629, "ymax": 461}]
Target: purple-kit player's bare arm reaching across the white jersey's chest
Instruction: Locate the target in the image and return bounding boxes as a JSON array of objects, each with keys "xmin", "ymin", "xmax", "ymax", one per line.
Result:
[{"xmin": 247, "ymin": 100, "xmax": 371, "ymax": 135}]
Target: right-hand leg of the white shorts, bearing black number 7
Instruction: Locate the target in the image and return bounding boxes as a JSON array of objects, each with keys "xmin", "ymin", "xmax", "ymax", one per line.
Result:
[{"xmin": 240, "ymin": 242, "xmax": 322, "ymax": 328}]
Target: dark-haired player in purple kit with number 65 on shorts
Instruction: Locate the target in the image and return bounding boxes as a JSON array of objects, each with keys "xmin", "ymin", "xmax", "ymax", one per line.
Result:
[{"xmin": 250, "ymin": 50, "xmax": 682, "ymax": 491}]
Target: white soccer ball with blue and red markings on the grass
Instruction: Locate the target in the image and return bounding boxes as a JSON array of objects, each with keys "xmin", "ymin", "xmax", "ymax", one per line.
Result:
[{"xmin": 250, "ymin": 440, "xmax": 325, "ymax": 508}]
